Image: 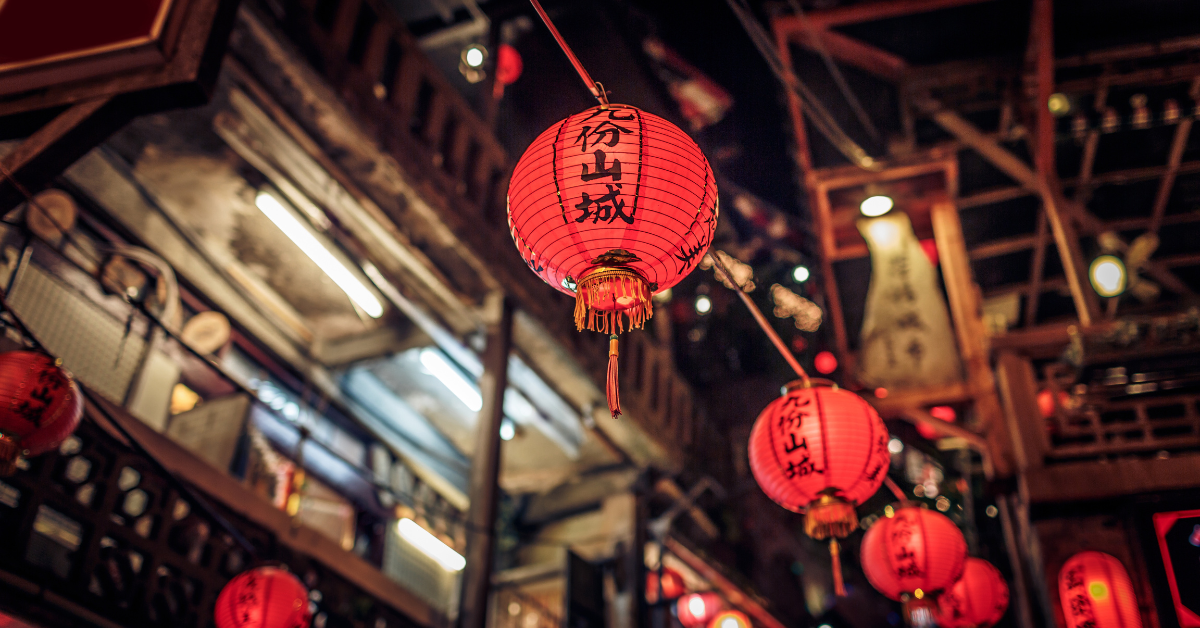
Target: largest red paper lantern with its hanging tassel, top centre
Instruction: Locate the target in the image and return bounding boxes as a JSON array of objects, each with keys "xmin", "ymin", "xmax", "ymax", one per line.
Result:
[{"xmin": 509, "ymin": 104, "xmax": 718, "ymax": 417}]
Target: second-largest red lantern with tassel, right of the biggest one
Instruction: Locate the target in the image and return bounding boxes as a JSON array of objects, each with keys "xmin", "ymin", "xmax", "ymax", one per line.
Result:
[{"xmin": 748, "ymin": 382, "xmax": 890, "ymax": 596}]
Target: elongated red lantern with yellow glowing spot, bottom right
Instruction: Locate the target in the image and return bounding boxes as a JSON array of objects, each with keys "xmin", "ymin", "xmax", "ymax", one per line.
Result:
[{"xmin": 1058, "ymin": 551, "xmax": 1141, "ymax": 628}]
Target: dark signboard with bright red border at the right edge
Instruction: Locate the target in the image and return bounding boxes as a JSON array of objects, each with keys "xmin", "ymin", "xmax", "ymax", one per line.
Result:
[{"xmin": 1153, "ymin": 510, "xmax": 1200, "ymax": 628}]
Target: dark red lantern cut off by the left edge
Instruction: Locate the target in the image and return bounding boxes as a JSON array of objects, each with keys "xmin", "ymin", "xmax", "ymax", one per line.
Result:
[{"xmin": 0, "ymin": 351, "xmax": 83, "ymax": 476}]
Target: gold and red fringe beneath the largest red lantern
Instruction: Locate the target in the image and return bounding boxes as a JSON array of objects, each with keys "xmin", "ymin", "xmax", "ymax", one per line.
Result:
[{"xmin": 575, "ymin": 268, "xmax": 654, "ymax": 334}]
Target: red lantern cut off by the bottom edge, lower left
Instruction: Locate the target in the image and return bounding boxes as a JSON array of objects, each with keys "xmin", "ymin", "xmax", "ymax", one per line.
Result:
[{"xmin": 212, "ymin": 567, "xmax": 312, "ymax": 628}]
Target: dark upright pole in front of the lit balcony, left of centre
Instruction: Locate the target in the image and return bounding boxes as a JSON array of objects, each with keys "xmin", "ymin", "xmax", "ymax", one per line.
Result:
[{"xmin": 458, "ymin": 293, "xmax": 512, "ymax": 628}]
